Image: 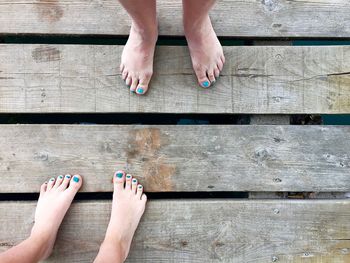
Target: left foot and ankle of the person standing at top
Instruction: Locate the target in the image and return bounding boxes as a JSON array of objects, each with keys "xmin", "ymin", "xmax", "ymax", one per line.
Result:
[{"xmin": 119, "ymin": 0, "xmax": 158, "ymax": 95}]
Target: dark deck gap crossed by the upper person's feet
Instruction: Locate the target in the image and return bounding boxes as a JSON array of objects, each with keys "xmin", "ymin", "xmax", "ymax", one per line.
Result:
[{"xmin": 0, "ymin": 34, "xmax": 350, "ymax": 46}]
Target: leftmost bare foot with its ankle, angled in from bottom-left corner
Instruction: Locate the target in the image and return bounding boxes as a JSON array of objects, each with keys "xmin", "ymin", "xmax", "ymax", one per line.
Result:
[{"xmin": 0, "ymin": 175, "xmax": 82, "ymax": 263}]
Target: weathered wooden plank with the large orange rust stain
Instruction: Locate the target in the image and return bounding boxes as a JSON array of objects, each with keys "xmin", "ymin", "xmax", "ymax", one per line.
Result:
[{"xmin": 0, "ymin": 125, "xmax": 350, "ymax": 193}]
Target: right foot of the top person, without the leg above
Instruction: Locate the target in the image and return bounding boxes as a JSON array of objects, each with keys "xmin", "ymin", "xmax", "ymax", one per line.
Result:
[{"xmin": 184, "ymin": 15, "xmax": 225, "ymax": 88}]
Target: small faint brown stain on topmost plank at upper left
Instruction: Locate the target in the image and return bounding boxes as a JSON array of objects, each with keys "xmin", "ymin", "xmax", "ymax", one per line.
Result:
[{"xmin": 37, "ymin": 0, "xmax": 64, "ymax": 23}]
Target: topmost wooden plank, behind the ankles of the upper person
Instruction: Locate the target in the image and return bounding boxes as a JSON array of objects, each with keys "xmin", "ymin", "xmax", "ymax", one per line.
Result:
[{"xmin": 0, "ymin": 0, "xmax": 350, "ymax": 38}]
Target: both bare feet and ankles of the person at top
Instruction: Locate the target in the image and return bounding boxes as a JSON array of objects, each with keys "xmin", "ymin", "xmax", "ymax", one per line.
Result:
[{"xmin": 119, "ymin": 0, "xmax": 225, "ymax": 95}]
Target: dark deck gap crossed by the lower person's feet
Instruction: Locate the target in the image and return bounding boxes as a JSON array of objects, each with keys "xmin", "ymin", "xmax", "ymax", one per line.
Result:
[{"xmin": 0, "ymin": 192, "xmax": 248, "ymax": 201}]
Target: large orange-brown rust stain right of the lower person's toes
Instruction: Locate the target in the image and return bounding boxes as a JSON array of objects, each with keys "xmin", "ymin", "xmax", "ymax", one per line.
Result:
[{"xmin": 126, "ymin": 128, "xmax": 176, "ymax": 191}]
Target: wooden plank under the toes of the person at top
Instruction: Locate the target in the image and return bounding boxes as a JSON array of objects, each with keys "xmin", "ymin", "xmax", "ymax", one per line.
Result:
[{"xmin": 0, "ymin": 45, "xmax": 350, "ymax": 114}]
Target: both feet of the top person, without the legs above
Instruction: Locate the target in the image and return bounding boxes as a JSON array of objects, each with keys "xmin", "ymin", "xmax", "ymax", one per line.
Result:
[{"xmin": 120, "ymin": 9, "xmax": 225, "ymax": 95}]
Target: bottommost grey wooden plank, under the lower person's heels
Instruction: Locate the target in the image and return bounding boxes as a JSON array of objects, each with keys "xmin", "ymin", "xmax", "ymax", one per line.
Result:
[{"xmin": 0, "ymin": 200, "xmax": 350, "ymax": 263}]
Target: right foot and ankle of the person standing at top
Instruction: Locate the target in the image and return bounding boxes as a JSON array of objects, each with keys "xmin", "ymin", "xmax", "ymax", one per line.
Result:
[{"xmin": 182, "ymin": 0, "xmax": 225, "ymax": 88}]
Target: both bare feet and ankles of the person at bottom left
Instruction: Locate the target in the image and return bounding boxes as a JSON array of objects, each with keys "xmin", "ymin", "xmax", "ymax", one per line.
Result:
[{"xmin": 0, "ymin": 171, "xmax": 147, "ymax": 263}]
